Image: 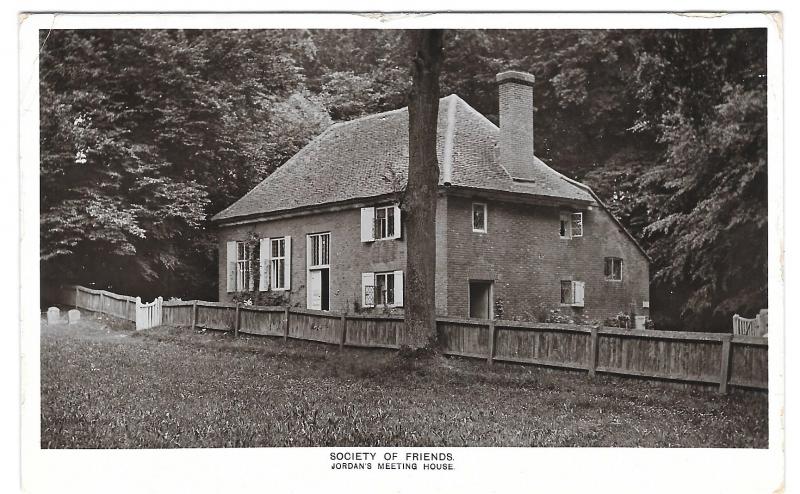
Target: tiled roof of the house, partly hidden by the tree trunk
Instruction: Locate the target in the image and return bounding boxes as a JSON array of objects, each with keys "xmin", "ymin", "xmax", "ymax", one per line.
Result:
[{"xmin": 213, "ymin": 95, "xmax": 594, "ymax": 220}]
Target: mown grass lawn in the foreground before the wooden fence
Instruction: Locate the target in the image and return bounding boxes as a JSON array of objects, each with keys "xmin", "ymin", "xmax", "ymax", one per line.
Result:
[{"xmin": 41, "ymin": 312, "xmax": 768, "ymax": 448}]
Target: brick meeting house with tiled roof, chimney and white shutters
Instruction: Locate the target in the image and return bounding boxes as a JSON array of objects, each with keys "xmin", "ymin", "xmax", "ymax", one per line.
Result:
[{"xmin": 213, "ymin": 72, "xmax": 649, "ymax": 320}]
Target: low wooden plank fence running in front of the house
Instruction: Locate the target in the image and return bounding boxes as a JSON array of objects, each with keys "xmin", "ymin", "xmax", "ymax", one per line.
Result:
[{"xmin": 56, "ymin": 287, "xmax": 768, "ymax": 393}]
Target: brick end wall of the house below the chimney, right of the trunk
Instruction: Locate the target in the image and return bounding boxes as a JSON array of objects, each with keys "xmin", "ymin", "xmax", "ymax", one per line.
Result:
[{"xmin": 447, "ymin": 197, "xmax": 650, "ymax": 320}]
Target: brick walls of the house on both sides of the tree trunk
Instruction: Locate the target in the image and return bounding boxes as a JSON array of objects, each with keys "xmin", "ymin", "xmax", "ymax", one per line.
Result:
[{"xmin": 219, "ymin": 191, "xmax": 649, "ymax": 320}]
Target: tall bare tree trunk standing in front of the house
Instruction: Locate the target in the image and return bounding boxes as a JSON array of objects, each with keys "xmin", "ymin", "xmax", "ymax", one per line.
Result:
[{"xmin": 401, "ymin": 30, "xmax": 442, "ymax": 348}]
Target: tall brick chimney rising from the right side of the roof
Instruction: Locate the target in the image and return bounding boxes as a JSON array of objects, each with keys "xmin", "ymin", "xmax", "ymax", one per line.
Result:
[{"xmin": 497, "ymin": 70, "xmax": 536, "ymax": 182}]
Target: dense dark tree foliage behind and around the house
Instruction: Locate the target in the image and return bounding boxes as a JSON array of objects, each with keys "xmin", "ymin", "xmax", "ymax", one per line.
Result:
[{"xmin": 40, "ymin": 29, "xmax": 767, "ymax": 329}]
